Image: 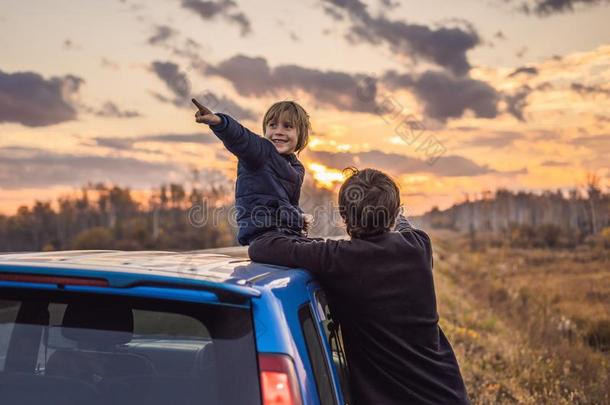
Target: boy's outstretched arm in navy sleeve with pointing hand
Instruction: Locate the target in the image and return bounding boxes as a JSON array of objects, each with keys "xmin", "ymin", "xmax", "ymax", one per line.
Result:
[{"xmin": 192, "ymin": 99, "xmax": 274, "ymax": 166}]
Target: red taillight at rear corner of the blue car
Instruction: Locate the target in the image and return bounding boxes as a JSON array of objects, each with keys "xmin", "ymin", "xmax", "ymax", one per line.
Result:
[{"xmin": 258, "ymin": 353, "xmax": 302, "ymax": 405}]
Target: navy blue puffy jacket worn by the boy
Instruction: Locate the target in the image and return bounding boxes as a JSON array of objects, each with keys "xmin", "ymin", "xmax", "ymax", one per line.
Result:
[{"xmin": 210, "ymin": 114, "xmax": 305, "ymax": 245}]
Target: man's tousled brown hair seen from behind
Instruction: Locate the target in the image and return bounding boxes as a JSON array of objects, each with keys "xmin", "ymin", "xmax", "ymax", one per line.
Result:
[{"xmin": 339, "ymin": 167, "xmax": 400, "ymax": 238}]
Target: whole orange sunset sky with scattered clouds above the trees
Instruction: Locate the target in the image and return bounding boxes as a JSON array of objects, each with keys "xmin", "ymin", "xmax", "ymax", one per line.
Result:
[{"xmin": 0, "ymin": 0, "xmax": 610, "ymax": 214}]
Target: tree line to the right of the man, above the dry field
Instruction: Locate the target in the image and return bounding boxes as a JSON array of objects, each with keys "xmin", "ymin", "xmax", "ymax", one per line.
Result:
[{"xmin": 421, "ymin": 175, "xmax": 610, "ymax": 247}]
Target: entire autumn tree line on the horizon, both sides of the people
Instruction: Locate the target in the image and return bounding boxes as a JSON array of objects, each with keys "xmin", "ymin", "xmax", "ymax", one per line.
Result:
[{"xmin": 0, "ymin": 175, "xmax": 610, "ymax": 252}]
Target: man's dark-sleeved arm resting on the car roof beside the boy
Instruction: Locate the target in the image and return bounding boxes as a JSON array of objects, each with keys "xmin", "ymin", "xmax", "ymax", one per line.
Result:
[{"xmin": 248, "ymin": 233, "xmax": 341, "ymax": 275}]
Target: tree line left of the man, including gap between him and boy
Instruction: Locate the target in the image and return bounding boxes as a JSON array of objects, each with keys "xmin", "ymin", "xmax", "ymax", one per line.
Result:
[{"xmin": 0, "ymin": 180, "xmax": 341, "ymax": 252}]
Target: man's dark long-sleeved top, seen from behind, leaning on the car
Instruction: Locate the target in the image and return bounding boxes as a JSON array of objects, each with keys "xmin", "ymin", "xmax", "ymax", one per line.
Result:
[{"xmin": 249, "ymin": 218, "xmax": 468, "ymax": 405}]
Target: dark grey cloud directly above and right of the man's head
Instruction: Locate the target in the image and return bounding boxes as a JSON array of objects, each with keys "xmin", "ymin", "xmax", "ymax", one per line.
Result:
[{"xmin": 382, "ymin": 71, "xmax": 501, "ymax": 122}]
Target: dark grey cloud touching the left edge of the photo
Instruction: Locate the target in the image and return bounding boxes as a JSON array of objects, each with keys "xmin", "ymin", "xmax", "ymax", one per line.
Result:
[{"xmin": 0, "ymin": 70, "xmax": 84, "ymax": 127}]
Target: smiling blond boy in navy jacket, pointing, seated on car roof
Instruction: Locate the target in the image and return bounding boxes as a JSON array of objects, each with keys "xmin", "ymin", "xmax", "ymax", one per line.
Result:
[{"xmin": 192, "ymin": 99, "xmax": 310, "ymax": 245}]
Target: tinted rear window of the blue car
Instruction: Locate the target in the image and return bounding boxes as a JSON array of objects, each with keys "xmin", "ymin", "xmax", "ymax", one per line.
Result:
[{"xmin": 0, "ymin": 289, "xmax": 260, "ymax": 405}]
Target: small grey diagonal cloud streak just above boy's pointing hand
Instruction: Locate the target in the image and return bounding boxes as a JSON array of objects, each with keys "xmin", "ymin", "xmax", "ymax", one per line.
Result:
[{"xmin": 152, "ymin": 61, "xmax": 256, "ymax": 120}]
